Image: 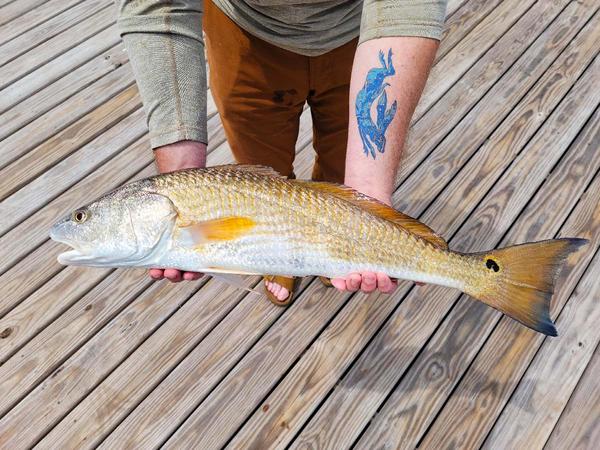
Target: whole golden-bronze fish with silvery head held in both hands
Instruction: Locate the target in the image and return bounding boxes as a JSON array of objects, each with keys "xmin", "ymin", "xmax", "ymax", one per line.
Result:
[{"xmin": 50, "ymin": 165, "xmax": 587, "ymax": 336}]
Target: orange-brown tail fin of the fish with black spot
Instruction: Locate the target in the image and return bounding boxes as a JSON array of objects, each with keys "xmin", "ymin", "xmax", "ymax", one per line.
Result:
[{"xmin": 465, "ymin": 238, "xmax": 588, "ymax": 336}]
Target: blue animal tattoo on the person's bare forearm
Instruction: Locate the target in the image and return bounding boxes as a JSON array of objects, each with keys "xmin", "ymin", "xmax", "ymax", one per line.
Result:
[{"xmin": 356, "ymin": 49, "xmax": 398, "ymax": 159}]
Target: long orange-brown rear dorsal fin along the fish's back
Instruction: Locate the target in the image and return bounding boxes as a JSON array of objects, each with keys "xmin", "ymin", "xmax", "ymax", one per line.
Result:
[{"xmin": 291, "ymin": 180, "xmax": 448, "ymax": 250}]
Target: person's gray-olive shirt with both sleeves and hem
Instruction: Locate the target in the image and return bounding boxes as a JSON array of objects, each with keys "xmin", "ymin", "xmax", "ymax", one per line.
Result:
[{"xmin": 118, "ymin": 0, "xmax": 446, "ymax": 148}]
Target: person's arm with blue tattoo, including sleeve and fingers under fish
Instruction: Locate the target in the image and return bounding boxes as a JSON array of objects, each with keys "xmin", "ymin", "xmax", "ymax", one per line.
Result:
[{"xmin": 332, "ymin": 0, "xmax": 446, "ymax": 292}]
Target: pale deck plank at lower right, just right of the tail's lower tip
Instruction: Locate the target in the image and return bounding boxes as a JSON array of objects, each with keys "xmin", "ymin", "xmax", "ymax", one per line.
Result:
[{"xmin": 483, "ymin": 254, "xmax": 600, "ymax": 449}]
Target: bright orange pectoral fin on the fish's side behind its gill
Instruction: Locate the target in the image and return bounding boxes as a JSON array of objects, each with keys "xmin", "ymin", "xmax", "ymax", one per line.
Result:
[{"xmin": 180, "ymin": 216, "xmax": 256, "ymax": 245}]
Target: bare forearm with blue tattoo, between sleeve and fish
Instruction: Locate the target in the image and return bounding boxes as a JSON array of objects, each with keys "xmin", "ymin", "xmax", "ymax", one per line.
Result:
[{"xmin": 345, "ymin": 37, "xmax": 438, "ymax": 203}]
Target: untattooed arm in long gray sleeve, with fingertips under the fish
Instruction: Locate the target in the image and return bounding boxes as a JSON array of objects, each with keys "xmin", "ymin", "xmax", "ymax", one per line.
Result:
[{"xmin": 117, "ymin": 0, "xmax": 208, "ymax": 281}]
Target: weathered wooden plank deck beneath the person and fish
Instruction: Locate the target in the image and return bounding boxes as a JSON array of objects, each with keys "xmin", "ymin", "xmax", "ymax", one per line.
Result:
[{"xmin": 0, "ymin": 0, "xmax": 600, "ymax": 450}]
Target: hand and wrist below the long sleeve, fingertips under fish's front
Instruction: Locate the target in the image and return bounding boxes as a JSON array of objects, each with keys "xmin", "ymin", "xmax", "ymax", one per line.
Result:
[{"xmin": 149, "ymin": 141, "xmax": 206, "ymax": 283}]
